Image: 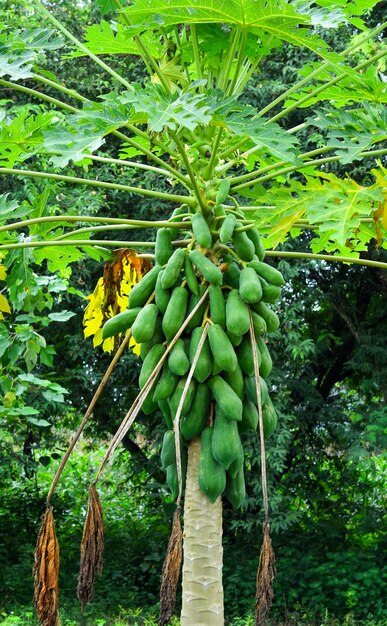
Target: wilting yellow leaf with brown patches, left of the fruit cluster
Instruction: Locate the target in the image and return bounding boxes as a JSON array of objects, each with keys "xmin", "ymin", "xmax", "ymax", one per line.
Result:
[{"xmin": 83, "ymin": 248, "xmax": 150, "ymax": 354}]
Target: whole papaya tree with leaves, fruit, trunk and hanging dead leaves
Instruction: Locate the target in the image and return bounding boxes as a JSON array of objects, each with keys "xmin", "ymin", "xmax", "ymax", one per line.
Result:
[{"xmin": 0, "ymin": 0, "xmax": 387, "ymax": 626}]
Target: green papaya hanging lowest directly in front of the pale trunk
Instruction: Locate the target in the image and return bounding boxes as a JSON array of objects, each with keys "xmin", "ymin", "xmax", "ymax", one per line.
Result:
[{"xmin": 199, "ymin": 426, "xmax": 226, "ymax": 503}]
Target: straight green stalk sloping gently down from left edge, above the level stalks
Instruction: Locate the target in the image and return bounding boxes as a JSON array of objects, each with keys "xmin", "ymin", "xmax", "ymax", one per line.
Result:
[{"xmin": 0, "ymin": 167, "xmax": 195, "ymax": 206}]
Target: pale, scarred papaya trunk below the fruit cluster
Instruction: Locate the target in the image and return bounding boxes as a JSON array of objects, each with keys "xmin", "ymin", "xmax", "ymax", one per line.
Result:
[{"xmin": 181, "ymin": 439, "xmax": 224, "ymax": 626}]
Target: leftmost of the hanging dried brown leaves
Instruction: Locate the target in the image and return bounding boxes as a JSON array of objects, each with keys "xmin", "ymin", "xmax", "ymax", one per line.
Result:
[{"xmin": 33, "ymin": 506, "xmax": 60, "ymax": 626}]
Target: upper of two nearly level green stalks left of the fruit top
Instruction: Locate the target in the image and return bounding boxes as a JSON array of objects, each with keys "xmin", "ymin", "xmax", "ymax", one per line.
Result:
[{"xmin": 0, "ymin": 215, "xmax": 187, "ymax": 232}]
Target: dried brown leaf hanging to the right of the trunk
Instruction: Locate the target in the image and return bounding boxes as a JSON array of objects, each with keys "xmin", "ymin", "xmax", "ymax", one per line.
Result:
[{"xmin": 255, "ymin": 522, "xmax": 276, "ymax": 626}]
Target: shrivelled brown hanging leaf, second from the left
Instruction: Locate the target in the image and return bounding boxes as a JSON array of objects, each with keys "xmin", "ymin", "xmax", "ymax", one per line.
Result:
[{"xmin": 77, "ymin": 484, "xmax": 103, "ymax": 610}]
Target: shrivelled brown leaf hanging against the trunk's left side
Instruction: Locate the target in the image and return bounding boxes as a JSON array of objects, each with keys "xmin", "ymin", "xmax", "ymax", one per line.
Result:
[{"xmin": 158, "ymin": 506, "xmax": 183, "ymax": 626}]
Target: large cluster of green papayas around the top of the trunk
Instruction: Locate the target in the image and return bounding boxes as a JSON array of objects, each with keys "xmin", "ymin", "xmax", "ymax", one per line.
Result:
[{"xmin": 103, "ymin": 194, "xmax": 284, "ymax": 508}]
